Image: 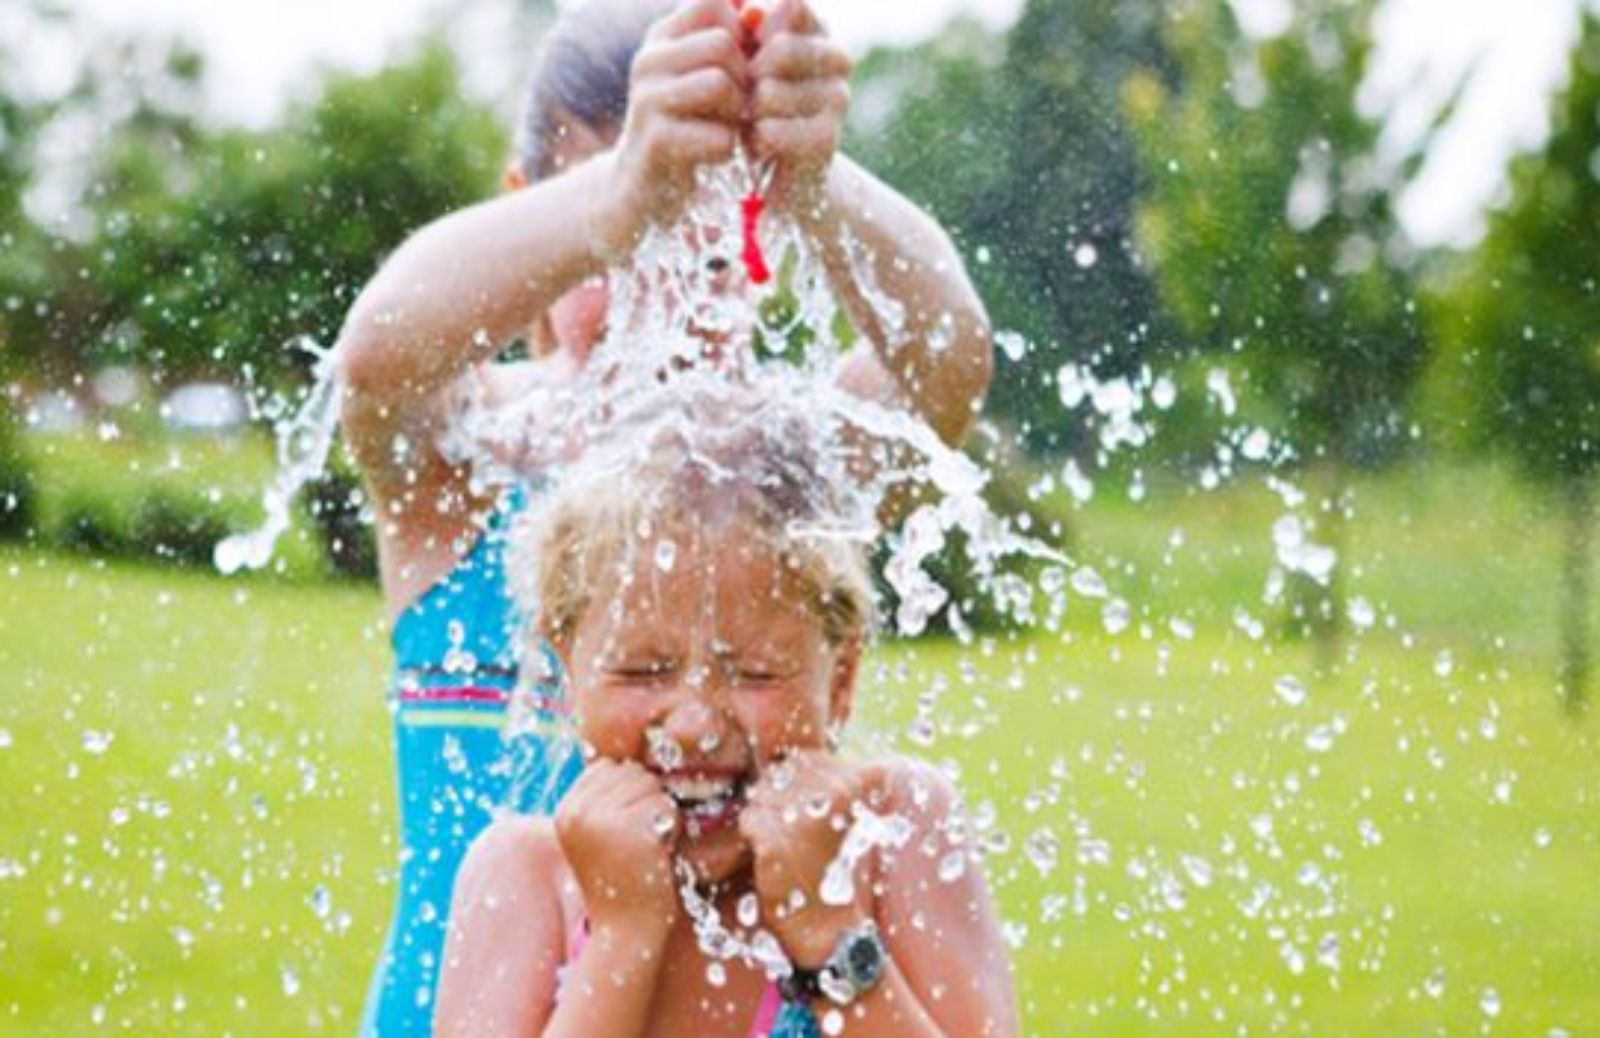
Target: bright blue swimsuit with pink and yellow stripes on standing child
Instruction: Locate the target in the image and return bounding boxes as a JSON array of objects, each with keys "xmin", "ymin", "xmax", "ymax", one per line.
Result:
[{"xmin": 362, "ymin": 494, "xmax": 582, "ymax": 1038}]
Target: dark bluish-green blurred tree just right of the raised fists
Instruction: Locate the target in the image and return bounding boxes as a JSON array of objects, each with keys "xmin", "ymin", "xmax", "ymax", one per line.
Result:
[{"xmin": 851, "ymin": 0, "xmax": 1168, "ymax": 451}]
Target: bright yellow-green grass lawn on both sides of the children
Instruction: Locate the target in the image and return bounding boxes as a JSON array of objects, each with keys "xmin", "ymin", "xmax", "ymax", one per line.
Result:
[{"xmin": 0, "ymin": 472, "xmax": 1600, "ymax": 1036}]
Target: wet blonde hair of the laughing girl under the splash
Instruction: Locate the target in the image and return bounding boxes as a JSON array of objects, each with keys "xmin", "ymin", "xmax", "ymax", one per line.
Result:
[{"xmin": 509, "ymin": 383, "xmax": 874, "ymax": 648}]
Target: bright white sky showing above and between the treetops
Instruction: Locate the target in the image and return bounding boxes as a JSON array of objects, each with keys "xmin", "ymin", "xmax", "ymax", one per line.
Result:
[{"xmin": 34, "ymin": 0, "xmax": 1582, "ymax": 245}]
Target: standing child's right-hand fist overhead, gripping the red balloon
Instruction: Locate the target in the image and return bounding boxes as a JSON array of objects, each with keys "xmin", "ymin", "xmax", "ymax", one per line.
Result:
[{"xmin": 749, "ymin": 0, "xmax": 851, "ymax": 219}]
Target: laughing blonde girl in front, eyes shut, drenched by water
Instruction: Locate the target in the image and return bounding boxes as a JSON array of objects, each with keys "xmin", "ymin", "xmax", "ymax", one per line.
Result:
[{"xmin": 435, "ymin": 393, "xmax": 1018, "ymax": 1038}]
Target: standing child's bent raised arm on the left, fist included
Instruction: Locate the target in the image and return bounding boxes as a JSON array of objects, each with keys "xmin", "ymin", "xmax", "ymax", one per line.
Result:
[{"xmin": 338, "ymin": 0, "xmax": 747, "ymax": 488}]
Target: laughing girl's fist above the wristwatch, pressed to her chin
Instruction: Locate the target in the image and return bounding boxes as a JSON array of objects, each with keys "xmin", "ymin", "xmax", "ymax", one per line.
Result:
[{"xmin": 739, "ymin": 750, "xmax": 878, "ymax": 969}]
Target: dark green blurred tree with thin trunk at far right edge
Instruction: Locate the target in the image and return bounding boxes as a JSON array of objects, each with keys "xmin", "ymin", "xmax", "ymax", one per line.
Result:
[{"xmin": 1434, "ymin": 13, "xmax": 1600, "ymax": 709}]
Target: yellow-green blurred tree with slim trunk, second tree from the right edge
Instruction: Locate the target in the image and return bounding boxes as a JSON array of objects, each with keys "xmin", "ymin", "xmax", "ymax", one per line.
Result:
[{"xmin": 1125, "ymin": 0, "xmax": 1426, "ymax": 652}]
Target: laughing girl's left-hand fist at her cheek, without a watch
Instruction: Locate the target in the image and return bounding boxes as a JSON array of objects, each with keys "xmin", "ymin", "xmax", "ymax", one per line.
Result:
[{"xmin": 555, "ymin": 760, "xmax": 678, "ymax": 936}]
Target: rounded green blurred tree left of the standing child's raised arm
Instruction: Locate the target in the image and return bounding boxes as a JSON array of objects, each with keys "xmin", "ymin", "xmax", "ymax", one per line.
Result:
[{"xmin": 38, "ymin": 40, "xmax": 506, "ymax": 385}]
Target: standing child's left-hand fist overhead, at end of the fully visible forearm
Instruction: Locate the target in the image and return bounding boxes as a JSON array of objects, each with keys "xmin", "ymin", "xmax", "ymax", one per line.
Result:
[{"xmin": 589, "ymin": 0, "xmax": 749, "ymax": 256}]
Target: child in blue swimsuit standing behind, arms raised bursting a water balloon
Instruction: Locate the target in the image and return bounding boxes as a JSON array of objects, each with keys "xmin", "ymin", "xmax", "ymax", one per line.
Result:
[{"xmin": 338, "ymin": 0, "xmax": 992, "ymax": 1038}]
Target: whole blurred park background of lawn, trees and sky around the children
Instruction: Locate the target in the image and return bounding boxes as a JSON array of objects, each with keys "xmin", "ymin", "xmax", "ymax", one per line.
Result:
[{"xmin": 0, "ymin": 0, "xmax": 1600, "ymax": 1035}]
